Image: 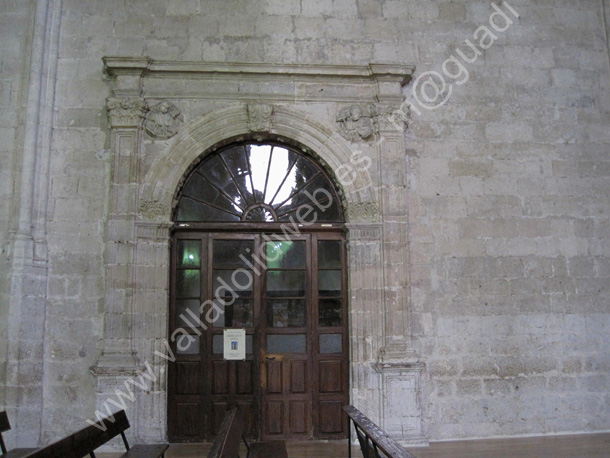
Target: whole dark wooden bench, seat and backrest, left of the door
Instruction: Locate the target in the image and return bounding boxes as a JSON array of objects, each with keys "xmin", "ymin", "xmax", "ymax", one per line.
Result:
[{"xmin": 24, "ymin": 410, "xmax": 169, "ymax": 458}]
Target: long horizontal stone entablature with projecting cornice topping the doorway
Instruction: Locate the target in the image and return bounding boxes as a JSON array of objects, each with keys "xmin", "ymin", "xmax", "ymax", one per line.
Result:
[{"xmin": 103, "ymin": 56, "xmax": 415, "ymax": 101}]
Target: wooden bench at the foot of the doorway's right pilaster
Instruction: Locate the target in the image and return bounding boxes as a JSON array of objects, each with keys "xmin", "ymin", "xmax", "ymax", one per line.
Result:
[{"xmin": 343, "ymin": 406, "xmax": 415, "ymax": 458}]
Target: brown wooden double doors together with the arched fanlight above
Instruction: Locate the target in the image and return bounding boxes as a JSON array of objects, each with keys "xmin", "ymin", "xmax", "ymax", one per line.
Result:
[{"xmin": 168, "ymin": 142, "xmax": 349, "ymax": 442}]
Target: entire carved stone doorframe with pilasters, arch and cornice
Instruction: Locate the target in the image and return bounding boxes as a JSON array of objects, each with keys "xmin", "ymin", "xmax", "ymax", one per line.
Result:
[{"xmin": 92, "ymin": 58, "xmax": 426, "ymax": 444}]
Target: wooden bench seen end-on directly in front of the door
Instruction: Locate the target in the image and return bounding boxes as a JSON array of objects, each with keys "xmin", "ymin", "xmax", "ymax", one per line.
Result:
[{"xmin": 208, "ymin": 409, "xmax": 288, "ymax": 458}]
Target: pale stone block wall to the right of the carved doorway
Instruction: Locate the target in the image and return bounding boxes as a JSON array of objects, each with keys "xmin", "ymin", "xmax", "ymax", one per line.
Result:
[{"xmin": 407, "ymin": 1, "xmax": 610, "ymax": 438}]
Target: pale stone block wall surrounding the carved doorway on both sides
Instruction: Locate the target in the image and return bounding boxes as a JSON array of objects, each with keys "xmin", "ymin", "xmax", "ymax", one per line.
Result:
[{"xmin": 0, "ymin": 0, "xmax": 610, "ymax": 441}]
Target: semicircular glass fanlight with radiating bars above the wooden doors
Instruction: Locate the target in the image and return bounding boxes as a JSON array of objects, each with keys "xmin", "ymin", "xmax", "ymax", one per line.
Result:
[{"xmin": 175, "ymin": 144, "xmax": 343, "ymax": 223}]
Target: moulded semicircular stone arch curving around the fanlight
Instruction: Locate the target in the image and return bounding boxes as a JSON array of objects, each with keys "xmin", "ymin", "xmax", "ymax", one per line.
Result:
[{"xmin": 140, "ymin": 105, "xmax": 376, "ymax": 221}]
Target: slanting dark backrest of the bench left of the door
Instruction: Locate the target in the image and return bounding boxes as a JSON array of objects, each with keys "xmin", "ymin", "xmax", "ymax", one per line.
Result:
[{"xmin": 27, "ymin": 410, "xmax": 129, "ymax": 458}]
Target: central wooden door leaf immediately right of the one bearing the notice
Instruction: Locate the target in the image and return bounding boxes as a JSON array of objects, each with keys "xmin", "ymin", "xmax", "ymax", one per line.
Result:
[{"xmin": 260, "ymin": 237, "xmax": 313, "ymax": 439}]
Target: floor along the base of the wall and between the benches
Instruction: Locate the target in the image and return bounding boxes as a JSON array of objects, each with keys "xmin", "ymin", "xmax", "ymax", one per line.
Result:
[{"xmin": 96, "ymin": 433, "xmax": 610, "ymax": 458}]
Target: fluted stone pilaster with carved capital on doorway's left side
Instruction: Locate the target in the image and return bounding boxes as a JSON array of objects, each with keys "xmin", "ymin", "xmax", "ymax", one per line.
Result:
[{"xmin": 91, "ymin": 91, "xmax": 146, "ymax": 412}]
